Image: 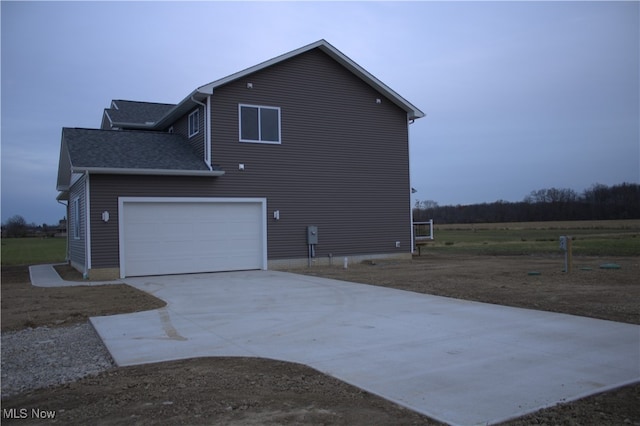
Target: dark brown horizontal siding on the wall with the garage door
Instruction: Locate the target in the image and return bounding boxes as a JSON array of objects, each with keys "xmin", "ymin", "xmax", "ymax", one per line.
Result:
[{"xmin": 91, "ymin": 49, "xmax": 411, "ymax": 268}]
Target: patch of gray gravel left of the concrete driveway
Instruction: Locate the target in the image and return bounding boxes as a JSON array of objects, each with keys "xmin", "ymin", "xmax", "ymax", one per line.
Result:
[{"xmin": 1, "ymin": 322, "xmax": 116, "ymax": 399}]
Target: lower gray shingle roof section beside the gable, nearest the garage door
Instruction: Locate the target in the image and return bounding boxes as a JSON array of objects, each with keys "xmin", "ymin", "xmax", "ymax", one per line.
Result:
[{"xmin": 62, "ymin": 127, "xmax": 209, "ymax": 171}]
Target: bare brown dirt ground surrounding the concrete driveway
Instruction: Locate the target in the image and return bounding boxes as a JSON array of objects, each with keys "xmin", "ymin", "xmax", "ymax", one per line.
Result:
[{"xmin": 2, "ymin": 254, "xmax": 640, "ymax": 426}]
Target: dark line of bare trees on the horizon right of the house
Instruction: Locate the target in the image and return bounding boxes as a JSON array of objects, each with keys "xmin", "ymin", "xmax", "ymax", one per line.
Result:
[{"xmin": 413, "ymin": 183, "xmax": 640, "ymax": 223}]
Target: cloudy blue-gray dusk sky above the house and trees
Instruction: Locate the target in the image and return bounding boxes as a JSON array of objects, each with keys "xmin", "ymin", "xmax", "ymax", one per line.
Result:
[{"xmin": 0, "ymin": 1, "xmax": 640, "ymax": 224}]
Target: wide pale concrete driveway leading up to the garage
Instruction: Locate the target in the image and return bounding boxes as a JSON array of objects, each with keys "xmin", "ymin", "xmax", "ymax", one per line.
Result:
[{"xmin": 91, "ymin": 271, "xmax": 640, "ymax": 425}]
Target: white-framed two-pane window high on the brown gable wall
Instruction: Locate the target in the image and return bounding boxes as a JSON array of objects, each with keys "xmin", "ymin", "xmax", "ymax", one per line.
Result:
[{"xmin": 238, "ymin": 104, "xmax": 280, "ymax": 144}]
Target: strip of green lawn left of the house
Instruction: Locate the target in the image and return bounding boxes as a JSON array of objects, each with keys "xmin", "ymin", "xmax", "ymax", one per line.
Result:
[{"xmin": 2, "ymin": 238, "xmax": 67, "ymax": 266}]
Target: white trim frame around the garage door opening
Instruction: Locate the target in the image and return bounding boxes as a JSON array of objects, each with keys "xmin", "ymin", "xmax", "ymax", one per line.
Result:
[{"xmin": 118, "ymin": 197, "xmax": 268, "ymax": 278}]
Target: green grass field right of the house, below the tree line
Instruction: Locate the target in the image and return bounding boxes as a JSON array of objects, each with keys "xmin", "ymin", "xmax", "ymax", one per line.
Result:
[{"xmin": 422, "ymin": 220, "xmax": 640, "ymax": 256}]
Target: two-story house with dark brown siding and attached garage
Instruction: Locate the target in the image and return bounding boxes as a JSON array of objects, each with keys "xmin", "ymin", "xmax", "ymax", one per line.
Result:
[{"xmin": 57, "ymin": 40, "xmax": 424, "ymax": 279}]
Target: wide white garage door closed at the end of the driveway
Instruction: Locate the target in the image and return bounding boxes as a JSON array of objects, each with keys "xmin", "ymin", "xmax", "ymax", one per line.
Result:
[{"xmin": 120, "ymin": 199, "xmax": 266, "ymax": 277}]
